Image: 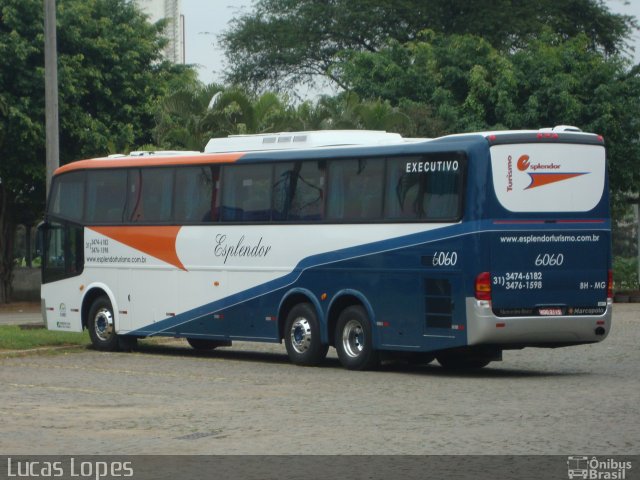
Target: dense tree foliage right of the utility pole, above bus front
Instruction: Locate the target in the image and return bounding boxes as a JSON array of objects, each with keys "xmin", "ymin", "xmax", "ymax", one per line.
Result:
[{"xmin": 58, "ymin": 0, "xmax": 192, "ymax": 163}]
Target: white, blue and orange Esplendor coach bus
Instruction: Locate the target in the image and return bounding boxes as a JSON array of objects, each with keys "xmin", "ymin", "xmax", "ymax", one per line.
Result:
[{"xmin": 41, "ymin": 126, "xmax": 612, "ymax": 370}]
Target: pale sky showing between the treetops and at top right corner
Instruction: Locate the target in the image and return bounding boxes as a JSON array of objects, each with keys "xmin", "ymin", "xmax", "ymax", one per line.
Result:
[{"xmin": 181, "ymin": 0, "xmax": 640, "ymax": 87}]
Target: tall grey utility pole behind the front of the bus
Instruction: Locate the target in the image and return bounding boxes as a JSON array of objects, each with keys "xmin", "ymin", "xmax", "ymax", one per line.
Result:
[{"xmin": 44, "ymin": 0, "xmax": 60, "ymax": 196}]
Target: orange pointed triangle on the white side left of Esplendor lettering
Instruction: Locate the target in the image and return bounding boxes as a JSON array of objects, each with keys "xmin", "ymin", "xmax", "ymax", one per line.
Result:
[{"xmin": 88, "ymin": 226, "xmax": 186, "ymax": 270}]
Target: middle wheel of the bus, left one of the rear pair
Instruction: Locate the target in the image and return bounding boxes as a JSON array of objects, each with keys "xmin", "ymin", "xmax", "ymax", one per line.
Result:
[{"xmin": 284, "ymin": 303, "xmax": 329, "ymax": 366}]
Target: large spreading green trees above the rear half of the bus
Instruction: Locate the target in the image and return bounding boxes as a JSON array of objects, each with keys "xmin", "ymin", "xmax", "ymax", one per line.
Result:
[{"xmin": 222, "ymin": 0, "xmax": 640, "ymax": 211}]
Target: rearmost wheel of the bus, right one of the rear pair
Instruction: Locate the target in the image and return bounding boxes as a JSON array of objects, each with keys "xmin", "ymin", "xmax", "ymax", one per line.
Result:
[{"xmin": 335, "ymin": 305, "xmax": 380, "ymax": 370}]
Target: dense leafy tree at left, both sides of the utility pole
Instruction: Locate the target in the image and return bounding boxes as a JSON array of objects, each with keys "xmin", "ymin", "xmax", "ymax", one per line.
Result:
[{"xmin": 0, "ymin": 0, "xmax": 195, "ymax": 302}]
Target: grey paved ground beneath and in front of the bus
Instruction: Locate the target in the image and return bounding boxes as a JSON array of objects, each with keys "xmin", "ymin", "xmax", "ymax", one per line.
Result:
[{"xmin": 0, "ymin": 304, "xmax": 640, "ymax": 455}]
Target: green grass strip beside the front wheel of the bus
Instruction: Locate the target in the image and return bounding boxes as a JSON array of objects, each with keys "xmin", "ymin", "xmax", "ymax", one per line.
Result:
[{"xmin": 0, "ymin": 325, "xmax": 90, "ymax": 352}]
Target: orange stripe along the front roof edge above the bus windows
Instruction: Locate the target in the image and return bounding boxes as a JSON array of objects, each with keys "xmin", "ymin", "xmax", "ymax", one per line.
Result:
[{"xmin": 55, "ymin": 153, "xmax": 244, "ymax": 175}]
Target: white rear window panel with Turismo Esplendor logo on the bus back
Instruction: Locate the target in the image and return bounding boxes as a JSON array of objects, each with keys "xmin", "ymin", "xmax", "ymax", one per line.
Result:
[{"xmin": 491, "ymin": 143, "xmax": 606, "ymax": 212}]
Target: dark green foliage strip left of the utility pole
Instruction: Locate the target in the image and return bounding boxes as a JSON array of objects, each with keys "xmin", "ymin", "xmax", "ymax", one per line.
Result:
[{"xmin": 0, "ymin": 0, "xmax": 44, "ymax": 302}]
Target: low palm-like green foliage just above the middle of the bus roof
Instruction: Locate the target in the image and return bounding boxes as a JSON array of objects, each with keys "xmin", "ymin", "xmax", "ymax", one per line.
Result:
[{"xmin": 154, "ymin": 83, "xmax": 422, "ymax": 150}]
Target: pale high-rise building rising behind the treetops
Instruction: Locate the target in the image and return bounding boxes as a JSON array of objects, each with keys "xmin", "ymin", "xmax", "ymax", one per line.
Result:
[{"xmin": 134, "ymin": 0, "xmax": 185, "ymax": 63}]
